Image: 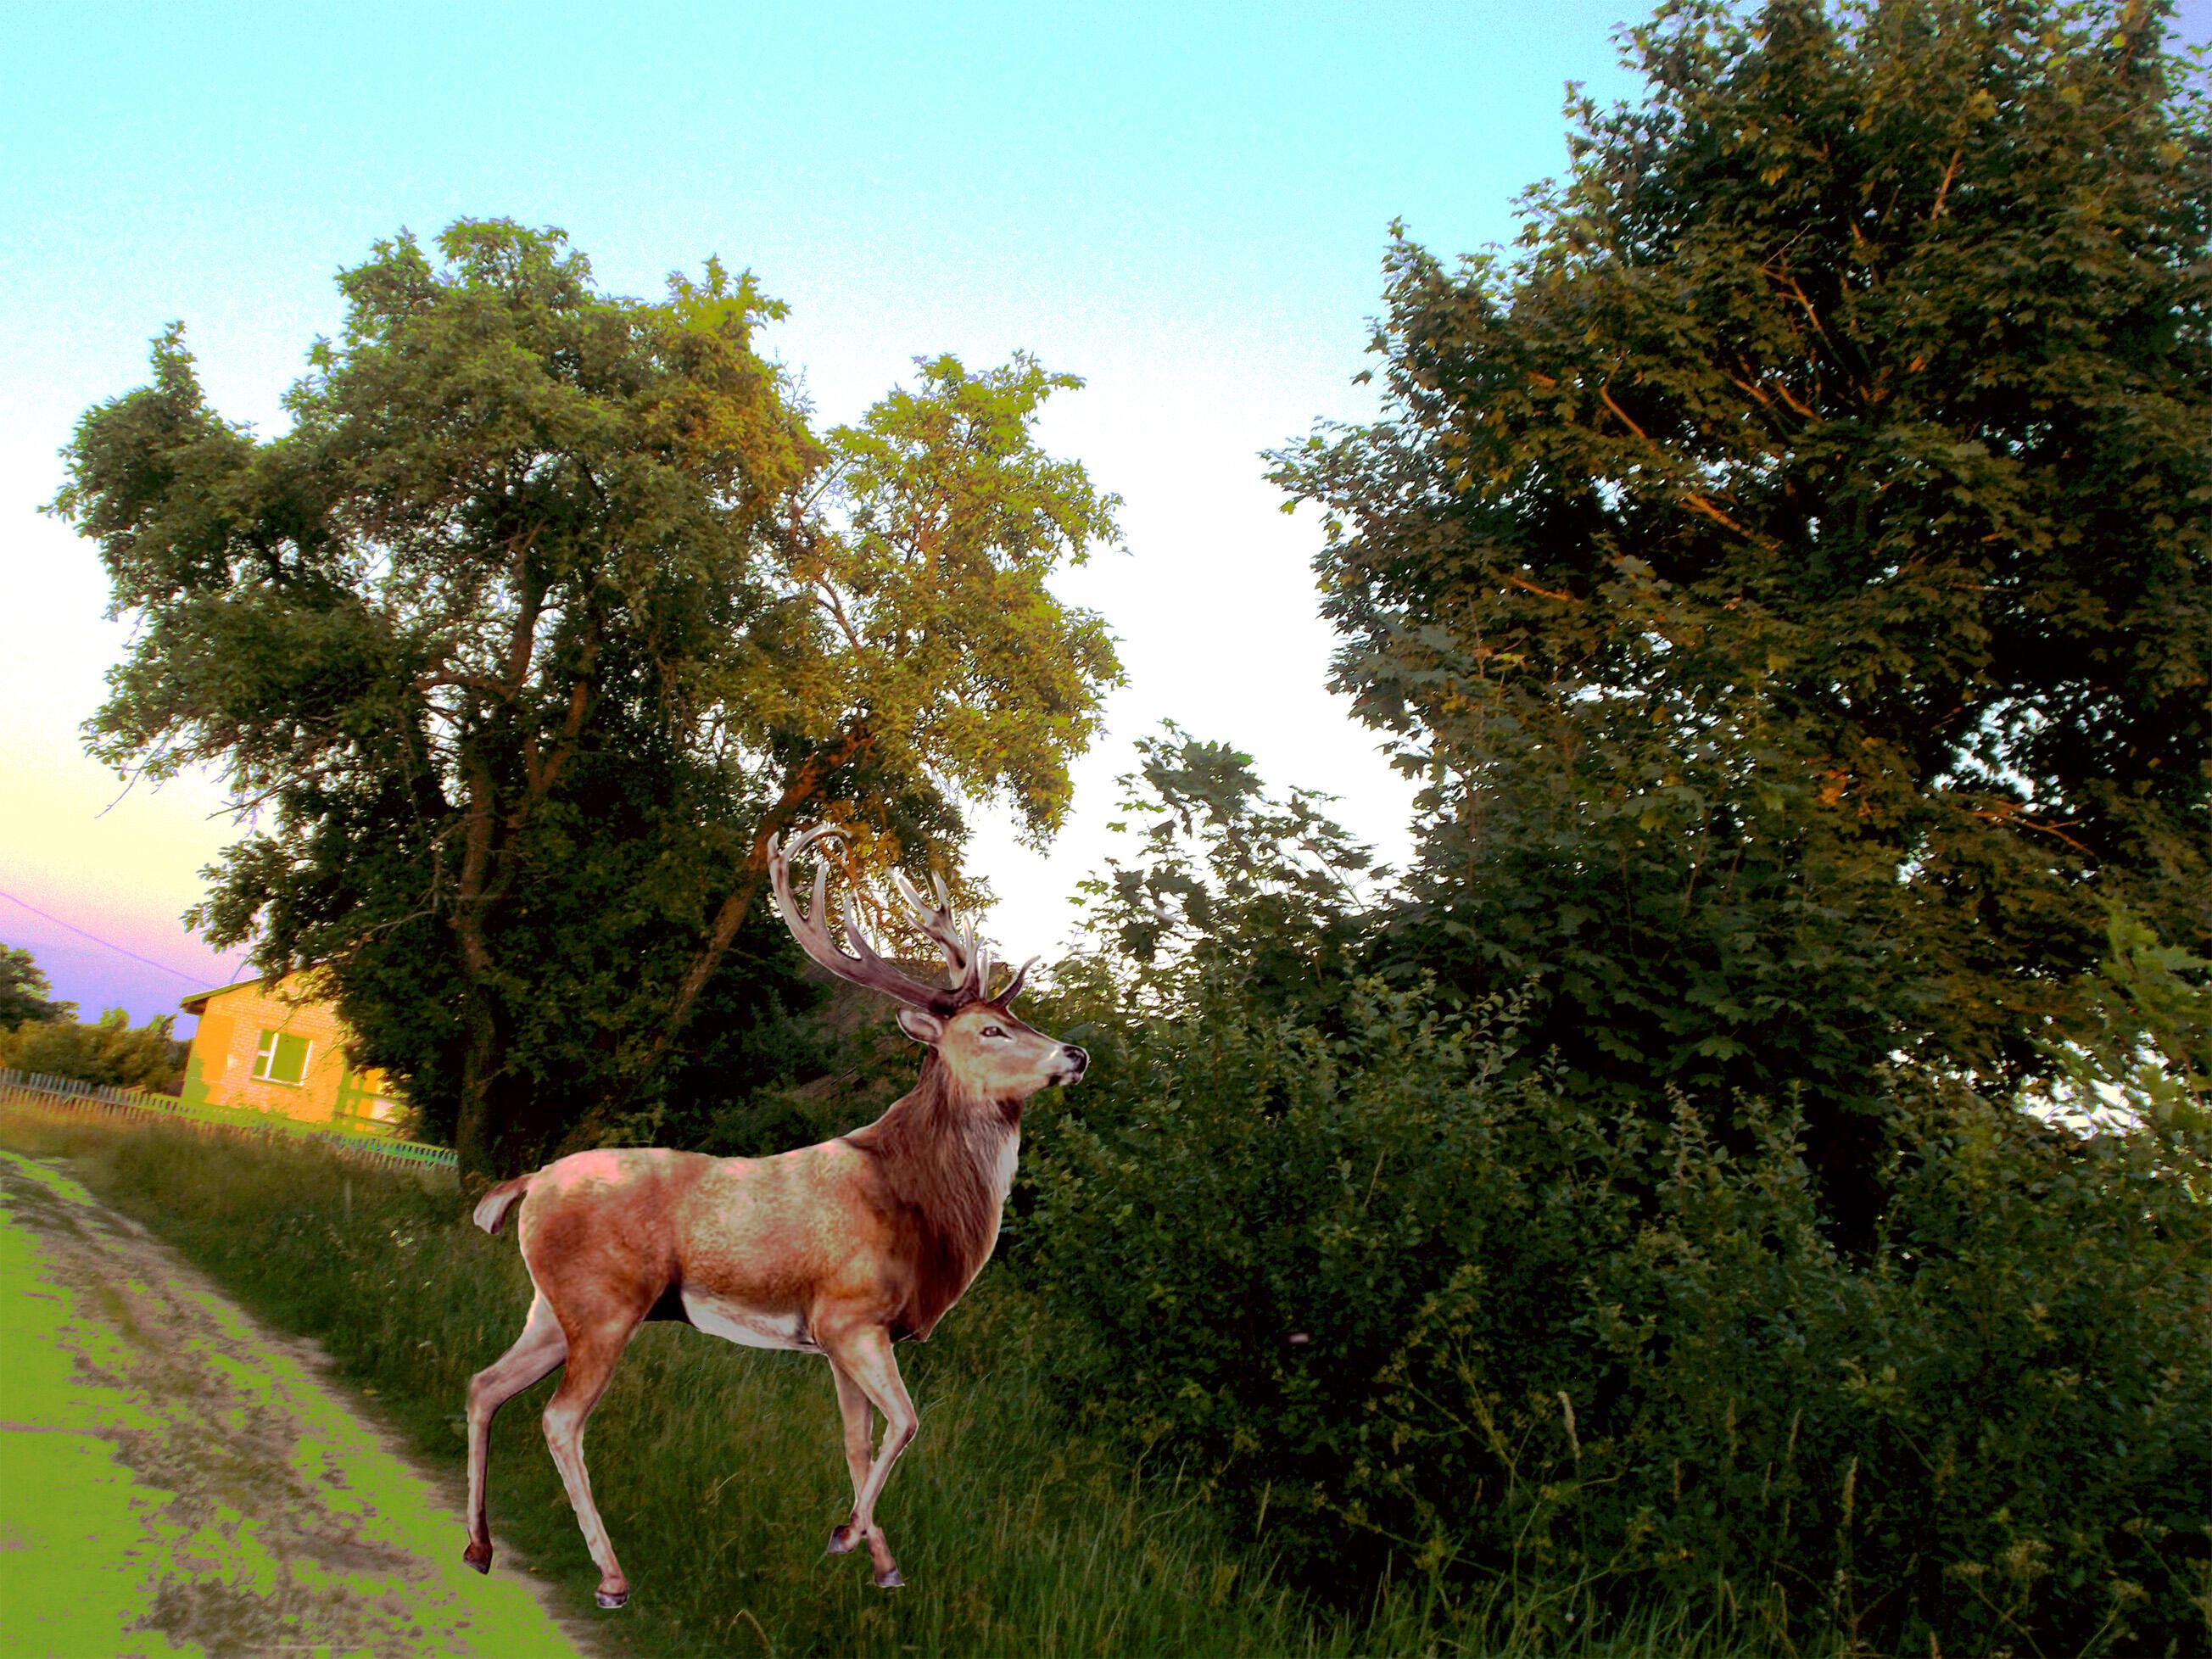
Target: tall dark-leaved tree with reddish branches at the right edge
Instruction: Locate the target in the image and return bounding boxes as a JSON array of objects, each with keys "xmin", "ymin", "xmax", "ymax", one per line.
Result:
[{"xmin": 1276, "ymin": 0, "xmax": 2212, "ymax": 1223}]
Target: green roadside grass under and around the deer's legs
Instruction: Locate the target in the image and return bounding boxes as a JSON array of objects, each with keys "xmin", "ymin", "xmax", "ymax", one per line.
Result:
[{"xmin": 0, "ymin": 1110, "xmax": 1831, "ymax": 1655}]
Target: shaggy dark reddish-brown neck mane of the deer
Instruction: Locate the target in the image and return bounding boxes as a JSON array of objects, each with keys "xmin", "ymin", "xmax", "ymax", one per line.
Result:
[{"xmin": 845, "ymin": 1051, "xmax": 1022, "ymax": 1336}]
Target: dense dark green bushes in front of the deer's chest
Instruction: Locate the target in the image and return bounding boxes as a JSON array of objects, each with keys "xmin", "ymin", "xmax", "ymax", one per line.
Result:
[{"xmin": 1013, "ymin": 974, "xmax": 2212, "ymax": 1652}]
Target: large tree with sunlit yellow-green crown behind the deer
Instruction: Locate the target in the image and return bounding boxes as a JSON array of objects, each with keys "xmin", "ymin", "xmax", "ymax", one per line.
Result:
[{"xmin": 55, "ymin": 221, "xmax": 1120, "ymax": 1176}]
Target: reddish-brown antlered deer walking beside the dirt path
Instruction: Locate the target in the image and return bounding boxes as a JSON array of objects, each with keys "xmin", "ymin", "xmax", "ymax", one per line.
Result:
[{"xmin": 462, "ymin": 825, "xmax": 1091, "ymax": 1608}]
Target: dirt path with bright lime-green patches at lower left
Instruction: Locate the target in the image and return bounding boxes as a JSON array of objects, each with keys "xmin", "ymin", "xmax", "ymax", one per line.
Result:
[{"xmin": 0, "ymin": 1150, "xmax": 578, "ymax": 1659}]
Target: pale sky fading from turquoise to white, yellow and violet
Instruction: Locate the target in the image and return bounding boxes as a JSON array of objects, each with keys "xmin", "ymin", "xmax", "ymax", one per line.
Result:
[{"xmin": 0, "ymin": 0, "xmax": 2212, "ymax": 1031}]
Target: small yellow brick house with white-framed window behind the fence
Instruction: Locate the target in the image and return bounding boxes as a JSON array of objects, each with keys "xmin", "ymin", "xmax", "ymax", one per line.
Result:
[{"xmin": 182, "ymin": 974, "xmax": 407, "ymax": 1132}]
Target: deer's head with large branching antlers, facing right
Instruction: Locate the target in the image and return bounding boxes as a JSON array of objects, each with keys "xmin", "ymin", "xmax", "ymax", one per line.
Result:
[{"xmin": 768, "ymin": 825, "xmax": 1091, "ymax": 1102}]
